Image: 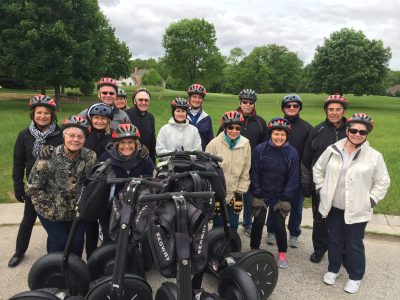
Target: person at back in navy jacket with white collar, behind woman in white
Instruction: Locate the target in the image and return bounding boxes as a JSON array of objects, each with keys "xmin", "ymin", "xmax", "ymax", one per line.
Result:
[{"xmin": 187, "ymin": 83, "xmax": 214, "ymax": 150}]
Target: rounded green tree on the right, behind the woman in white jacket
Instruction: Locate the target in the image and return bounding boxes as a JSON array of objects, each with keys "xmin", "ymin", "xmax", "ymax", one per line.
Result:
[{"xmin": 309, "ymin": 28, "xmax": 391, "ymax": 95}]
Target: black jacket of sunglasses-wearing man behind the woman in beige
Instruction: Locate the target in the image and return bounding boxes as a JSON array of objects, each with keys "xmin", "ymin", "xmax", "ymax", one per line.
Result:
[{"xmin": 217, "ymin": 110, "xmax": 268, "ymax": 152}]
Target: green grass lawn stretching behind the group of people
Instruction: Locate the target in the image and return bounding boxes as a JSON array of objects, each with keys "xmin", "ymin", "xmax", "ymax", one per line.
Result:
[{"xmin": 0, "ymin": 87, "xmax": 400, "ymax": 215}]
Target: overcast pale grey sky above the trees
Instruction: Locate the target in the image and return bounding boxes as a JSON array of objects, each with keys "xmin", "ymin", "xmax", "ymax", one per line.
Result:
[{"xmin": 99, "ymin": 0, "xmax": 400, "ymax": 70}]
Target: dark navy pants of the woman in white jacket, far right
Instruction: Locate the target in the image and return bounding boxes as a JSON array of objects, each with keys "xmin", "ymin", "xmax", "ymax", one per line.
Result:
[{"xmin": 327, "ymin": 207, "xmax": 367, "ymax": 280}]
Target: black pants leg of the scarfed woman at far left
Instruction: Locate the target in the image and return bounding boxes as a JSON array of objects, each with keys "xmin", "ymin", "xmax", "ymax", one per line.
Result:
[{"xmin": 15, "ymin": 197, "xmax": 37, "ymax": 256}]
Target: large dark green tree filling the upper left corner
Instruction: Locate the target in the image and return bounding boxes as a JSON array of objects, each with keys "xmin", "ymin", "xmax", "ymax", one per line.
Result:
[{"xmin": 0, "ymin": 0, "xmax": 129, "ymax": 102}]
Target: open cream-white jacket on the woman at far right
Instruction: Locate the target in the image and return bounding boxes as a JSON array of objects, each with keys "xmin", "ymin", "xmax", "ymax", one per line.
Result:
[{"xmin": 313, "ymin": 138, "xmax": 390, "ymax": 224}]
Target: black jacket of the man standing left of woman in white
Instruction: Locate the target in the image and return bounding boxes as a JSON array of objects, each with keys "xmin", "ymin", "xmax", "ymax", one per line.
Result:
[{"xmin": 125, "ymin": 107, "xmax": 156, "ymax": 163}]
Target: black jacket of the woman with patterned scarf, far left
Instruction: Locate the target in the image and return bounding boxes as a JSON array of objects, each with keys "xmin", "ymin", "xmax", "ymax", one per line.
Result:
[{"xmin": 12, "ymin": 126, "xmax": 63, "ymax": 199}]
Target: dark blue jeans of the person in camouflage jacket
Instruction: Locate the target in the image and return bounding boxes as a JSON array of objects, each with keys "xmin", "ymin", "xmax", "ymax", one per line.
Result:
[{"xmin": 38, "ymin": 215, "xmax": 85, "ymax": 256}]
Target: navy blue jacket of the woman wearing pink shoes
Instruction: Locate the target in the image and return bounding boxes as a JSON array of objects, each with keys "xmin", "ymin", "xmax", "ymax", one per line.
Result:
[{"xmin": 250, "ymin": 141, "xmax": 300, "ymax": 206}]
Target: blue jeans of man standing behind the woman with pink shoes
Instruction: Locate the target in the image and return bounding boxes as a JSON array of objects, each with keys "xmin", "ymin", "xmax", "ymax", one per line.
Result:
[{"xmin": 266, "ymin": 191, "xmax": 304, "ymax": 237}]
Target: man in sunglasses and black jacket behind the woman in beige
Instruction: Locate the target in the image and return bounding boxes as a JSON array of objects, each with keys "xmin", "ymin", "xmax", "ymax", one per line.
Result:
[{"xmin": 218, "ymin": 89, "xmax": 268, "ymax": 236}]
